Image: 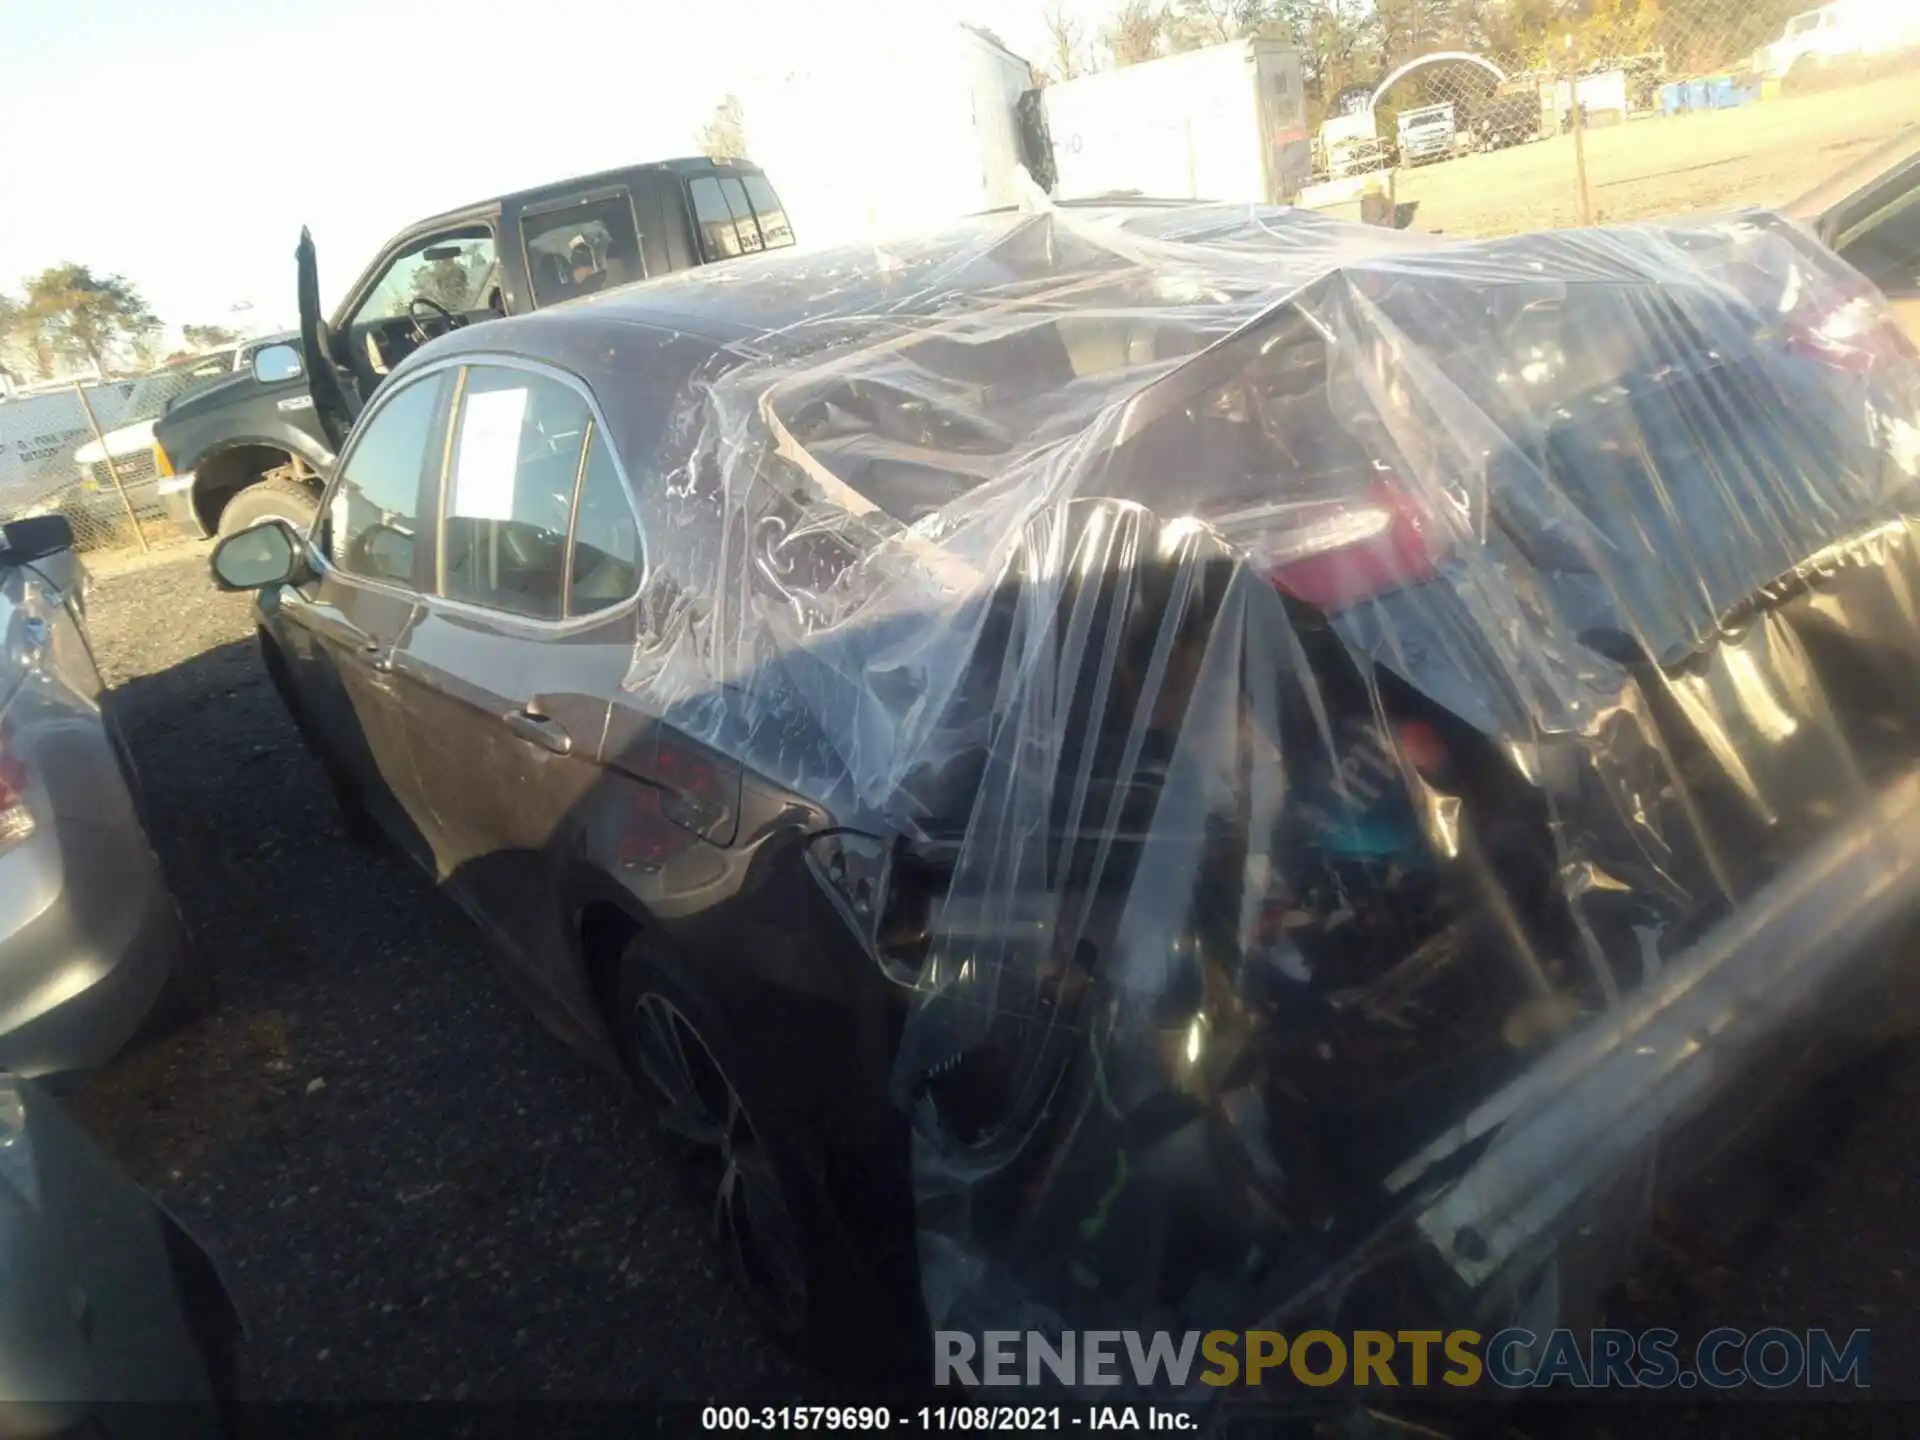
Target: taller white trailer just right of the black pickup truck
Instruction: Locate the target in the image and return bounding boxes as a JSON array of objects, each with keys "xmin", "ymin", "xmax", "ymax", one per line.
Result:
[{"xmin": 741, "ymin": 23, "xmax": 1033, "ymax": 246}]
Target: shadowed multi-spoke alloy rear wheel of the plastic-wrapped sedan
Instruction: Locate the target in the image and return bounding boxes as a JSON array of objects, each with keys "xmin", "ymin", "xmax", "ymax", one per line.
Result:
[{"xmin": 634, "ymin": 993, "xmax": 806, "ymax": 1332}]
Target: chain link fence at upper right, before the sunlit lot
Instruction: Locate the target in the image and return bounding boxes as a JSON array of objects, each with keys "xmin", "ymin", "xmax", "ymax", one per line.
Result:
[{"xmin": 1294, "ymin": 0, "xmax": 1920, "ymax": 234}]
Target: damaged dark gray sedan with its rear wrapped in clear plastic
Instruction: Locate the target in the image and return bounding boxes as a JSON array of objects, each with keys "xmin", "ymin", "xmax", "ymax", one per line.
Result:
[{"xmin": 215, "ymin": 197, "xmax": 1920, "ymax": 1382}]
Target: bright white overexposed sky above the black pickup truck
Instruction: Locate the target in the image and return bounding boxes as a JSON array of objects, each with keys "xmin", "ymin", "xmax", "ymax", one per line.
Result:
[{"xmin": 0, "ymin": 0, "xmax": 1096, "ymax": 347}]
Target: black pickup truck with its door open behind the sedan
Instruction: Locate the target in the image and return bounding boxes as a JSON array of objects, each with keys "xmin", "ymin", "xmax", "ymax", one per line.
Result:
[{"xmin": 154, "ymin": 157, "xmax": 793, "ymax": 536}]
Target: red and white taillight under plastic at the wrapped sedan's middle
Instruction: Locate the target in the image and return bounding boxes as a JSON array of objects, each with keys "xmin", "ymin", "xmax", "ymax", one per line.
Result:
[{"xmin": 1267, "ymin": 480, "xmax": 1446, "ymax": 611}]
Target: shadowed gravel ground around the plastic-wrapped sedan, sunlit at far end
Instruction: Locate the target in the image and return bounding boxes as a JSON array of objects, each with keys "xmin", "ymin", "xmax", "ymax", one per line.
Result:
[{"xmin": 56, "ymin": 553, "xmax": 1920, "ymax": 1434}]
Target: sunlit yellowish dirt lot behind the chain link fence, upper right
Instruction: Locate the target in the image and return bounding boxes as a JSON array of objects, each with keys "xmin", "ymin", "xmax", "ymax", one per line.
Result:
[{"xmin": 1396, "ymin": 79, "xmax": 1920, "ymax": 234}]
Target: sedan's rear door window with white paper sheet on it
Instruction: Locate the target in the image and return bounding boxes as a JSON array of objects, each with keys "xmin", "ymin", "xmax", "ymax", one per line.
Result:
[{"xmin": 438, "ymin": 365, "xmax": 591, "ymax": 620}]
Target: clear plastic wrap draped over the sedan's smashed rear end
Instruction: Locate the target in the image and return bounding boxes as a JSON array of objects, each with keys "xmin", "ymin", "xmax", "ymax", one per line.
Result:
[{"xmin": 606, "ymin": 197, "xmax": 1920, "ymax": 1382}]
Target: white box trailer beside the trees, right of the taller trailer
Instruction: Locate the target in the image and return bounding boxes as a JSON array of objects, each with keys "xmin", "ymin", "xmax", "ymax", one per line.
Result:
[{"xmin": 1044, "ymin": 40, "xmax": 1313, "ymax": 204}]
